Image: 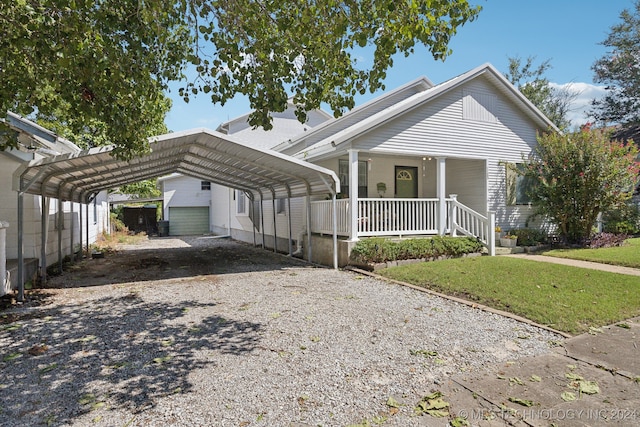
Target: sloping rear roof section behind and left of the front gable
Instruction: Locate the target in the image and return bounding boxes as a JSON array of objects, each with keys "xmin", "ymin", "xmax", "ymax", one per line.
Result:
[{"xmin": 273, "ymin": 77, "xmax": 433, "ymax": 155}]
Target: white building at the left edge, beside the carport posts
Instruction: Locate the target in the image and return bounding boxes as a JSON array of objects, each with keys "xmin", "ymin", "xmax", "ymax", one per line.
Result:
[{"xmin": 0, "ymin": 113, "xmax": 109, "ymax": 295}]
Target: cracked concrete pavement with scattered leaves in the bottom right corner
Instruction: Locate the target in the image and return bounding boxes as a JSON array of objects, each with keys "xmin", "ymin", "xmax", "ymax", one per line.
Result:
[{"xmin": 438, "ymin": 318, "xmax": 640, "ymax": 427}]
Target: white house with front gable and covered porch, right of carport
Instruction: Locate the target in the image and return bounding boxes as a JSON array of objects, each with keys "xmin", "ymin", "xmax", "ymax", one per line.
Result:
[{"xmin": 161, "ymin": 64, "xmax": 557, "ymax": 264}]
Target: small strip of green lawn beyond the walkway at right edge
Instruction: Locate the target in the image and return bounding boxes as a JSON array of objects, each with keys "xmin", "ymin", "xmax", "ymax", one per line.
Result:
[{"xmin": 541, "ymin": 238, "xmax": 640, "ymax": 268}]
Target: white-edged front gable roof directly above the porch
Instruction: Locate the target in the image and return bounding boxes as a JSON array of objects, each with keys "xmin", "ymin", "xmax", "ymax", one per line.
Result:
[{"xmin": 295, "ymin": 63, "xmax": 558, "ymax": 160}]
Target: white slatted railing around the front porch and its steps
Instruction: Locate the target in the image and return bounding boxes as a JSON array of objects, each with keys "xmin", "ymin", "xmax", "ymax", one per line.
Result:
[{"xmin": 311, "ymin": 195, "xmax": 495, "ymax": 251}]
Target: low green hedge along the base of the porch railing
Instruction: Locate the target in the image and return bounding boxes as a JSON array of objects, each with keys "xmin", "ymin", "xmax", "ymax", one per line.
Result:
[{"xmin": 351, "ymin": 236, "xmax": 482, "ymax": 264}]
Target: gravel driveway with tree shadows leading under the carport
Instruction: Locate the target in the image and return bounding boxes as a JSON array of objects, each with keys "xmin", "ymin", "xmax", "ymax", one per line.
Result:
[{"xmin": 0, "ymin": 238, "xmax": 561, "ymax": 426}]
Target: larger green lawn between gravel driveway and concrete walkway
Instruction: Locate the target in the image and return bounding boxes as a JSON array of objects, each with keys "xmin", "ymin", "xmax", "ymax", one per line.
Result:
[{"xmin": 380, "ymin": 256, "xmax": 640, "ymax": 334}]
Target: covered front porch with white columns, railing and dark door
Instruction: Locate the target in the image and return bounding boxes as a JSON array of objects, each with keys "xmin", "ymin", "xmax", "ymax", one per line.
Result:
[{"xmin": 311, "ymin": 150, "xmax": 495, "ymax": 255}]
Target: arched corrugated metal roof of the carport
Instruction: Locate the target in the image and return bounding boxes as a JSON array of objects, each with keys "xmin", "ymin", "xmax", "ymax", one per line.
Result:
[{"xmin": 13, "ymin": 129, "xmax": 340, "ymax": 203}]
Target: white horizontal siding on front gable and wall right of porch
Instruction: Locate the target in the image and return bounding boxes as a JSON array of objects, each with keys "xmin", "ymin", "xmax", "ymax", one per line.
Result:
[{"xmin": 352, "ymin": 78, "xmax": 537, "ymax": 231}]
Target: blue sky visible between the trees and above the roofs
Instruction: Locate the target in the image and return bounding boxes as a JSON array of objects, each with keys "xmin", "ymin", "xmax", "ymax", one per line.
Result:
[{"xmin": 166, "ymin": 0, "xmax": 634, "ymax": 131}]
